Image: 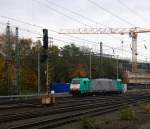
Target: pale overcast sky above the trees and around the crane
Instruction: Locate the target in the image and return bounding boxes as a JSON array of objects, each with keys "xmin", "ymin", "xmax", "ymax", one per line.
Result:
[{"xmin": 0, "ymin": 0, "xmax": 150, "ymax": 61}]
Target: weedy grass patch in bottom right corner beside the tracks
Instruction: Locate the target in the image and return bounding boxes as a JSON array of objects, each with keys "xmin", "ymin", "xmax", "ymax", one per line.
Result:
[{"xmin": 79, "ymin": 102, "xmax": 150, "ymax": 129}]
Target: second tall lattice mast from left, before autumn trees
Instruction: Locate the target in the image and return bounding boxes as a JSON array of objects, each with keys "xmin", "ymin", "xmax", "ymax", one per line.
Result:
[{"xmin": 15, "ymin": 27, "xmax": 21, "ymax": 95}]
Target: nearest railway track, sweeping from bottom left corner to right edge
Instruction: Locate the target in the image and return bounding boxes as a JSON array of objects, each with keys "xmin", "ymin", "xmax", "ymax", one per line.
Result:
[{"xmin": 0, "ymin": 93, "xmax": 150, "ymax": 129}]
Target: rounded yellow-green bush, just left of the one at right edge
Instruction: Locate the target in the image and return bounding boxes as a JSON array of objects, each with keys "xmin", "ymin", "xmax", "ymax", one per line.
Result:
[{"xmin": 120, "ymin": 106, "xmax": 135, "ymax": 120}]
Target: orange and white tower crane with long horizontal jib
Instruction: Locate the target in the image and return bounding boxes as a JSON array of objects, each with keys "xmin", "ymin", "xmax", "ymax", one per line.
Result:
[{"xmin": 59, "ymin": 27, "xmax": 150, "ymax": 72}]
